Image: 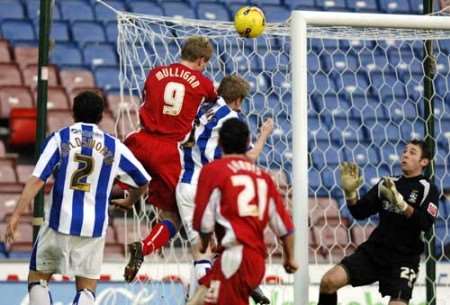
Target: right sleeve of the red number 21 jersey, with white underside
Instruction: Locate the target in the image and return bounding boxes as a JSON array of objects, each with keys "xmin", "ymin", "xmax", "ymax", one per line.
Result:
[{"xmin": 268, "ymin": 178, "xmax": 294, "ymax": 237}]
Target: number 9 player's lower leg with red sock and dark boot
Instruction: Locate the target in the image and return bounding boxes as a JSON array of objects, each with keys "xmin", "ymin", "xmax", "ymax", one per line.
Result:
[{"xmin": 124, "ymin": 210, "xmax": 180, "ymax": 282}]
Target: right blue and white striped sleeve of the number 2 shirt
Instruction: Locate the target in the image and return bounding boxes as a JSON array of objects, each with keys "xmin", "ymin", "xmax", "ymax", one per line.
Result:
[{"xmin": 117, "ymin": 143, "xmax": 151, "ymax": 188}]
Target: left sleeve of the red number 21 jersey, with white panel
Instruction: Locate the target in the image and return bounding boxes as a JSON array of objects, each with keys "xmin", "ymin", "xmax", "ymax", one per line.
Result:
[{"xmin": 192, "ymin": 167, "xmax": 221, "ymax": 233}]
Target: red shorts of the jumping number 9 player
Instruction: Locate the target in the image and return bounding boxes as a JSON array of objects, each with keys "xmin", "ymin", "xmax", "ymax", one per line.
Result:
[{"xmin": 124, "ymin": 130, "xmax": 181, "ymax": 212}]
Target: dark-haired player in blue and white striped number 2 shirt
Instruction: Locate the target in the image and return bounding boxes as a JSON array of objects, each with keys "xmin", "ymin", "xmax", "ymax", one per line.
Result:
[{"xmin": 5, "ymin": 92, "xmax": 150, "ymax": 305}]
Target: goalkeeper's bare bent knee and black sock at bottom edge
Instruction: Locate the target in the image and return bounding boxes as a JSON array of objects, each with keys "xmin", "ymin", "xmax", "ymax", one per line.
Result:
[{"xmin": 318, "ymin": 265, "xmax": 349, "ymax": 305}]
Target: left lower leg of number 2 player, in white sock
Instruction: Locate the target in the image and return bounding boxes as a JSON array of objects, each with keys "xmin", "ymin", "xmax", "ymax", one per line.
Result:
[{"xmin": 28, "ymin": 270, "xmax": 53, "ymax": 305}]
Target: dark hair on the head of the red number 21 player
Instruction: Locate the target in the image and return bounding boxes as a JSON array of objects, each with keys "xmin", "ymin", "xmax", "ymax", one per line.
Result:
[{"xmin": 219, "ymin": 118, "xmax": 250, "ymax": 154}]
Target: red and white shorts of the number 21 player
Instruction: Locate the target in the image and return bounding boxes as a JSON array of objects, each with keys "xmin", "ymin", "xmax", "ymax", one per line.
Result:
[{"xmin": 199, "ymin": 247, "xmax": 266, "ymax": 305}]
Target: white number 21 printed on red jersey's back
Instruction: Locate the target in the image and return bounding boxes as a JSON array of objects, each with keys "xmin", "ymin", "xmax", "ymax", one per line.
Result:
[{"xmin": 231, "ymin": 175, "xmax": 267, "ymax": 220}]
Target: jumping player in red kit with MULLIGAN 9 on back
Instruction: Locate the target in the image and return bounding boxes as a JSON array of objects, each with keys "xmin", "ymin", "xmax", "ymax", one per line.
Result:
[{"xmin": 124, "ymin": 36, "xmax": 217, "ymax": 282}]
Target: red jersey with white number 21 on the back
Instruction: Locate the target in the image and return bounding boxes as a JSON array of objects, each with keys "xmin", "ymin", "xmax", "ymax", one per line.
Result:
[{"xmin": 193, "ymin": 157, "xmax": 294, "ymax": 256}]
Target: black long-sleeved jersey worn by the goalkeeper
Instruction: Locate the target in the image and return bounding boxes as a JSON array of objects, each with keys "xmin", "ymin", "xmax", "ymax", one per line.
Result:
[{"xmin": 348, "ymin": 175, "xmax": 439, "ymax": 262}]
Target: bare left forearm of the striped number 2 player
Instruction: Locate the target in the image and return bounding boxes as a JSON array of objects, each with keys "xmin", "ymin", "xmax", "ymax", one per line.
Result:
[{"xmin": 4, "ymin": 176, "xmax": 45, "ymax": 243}]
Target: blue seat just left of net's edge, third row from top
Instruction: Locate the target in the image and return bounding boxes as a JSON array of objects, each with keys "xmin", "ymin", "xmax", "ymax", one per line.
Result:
[{"xmin": 83, "ymin": 43, "xmax": 117, "ymax": 67}]
